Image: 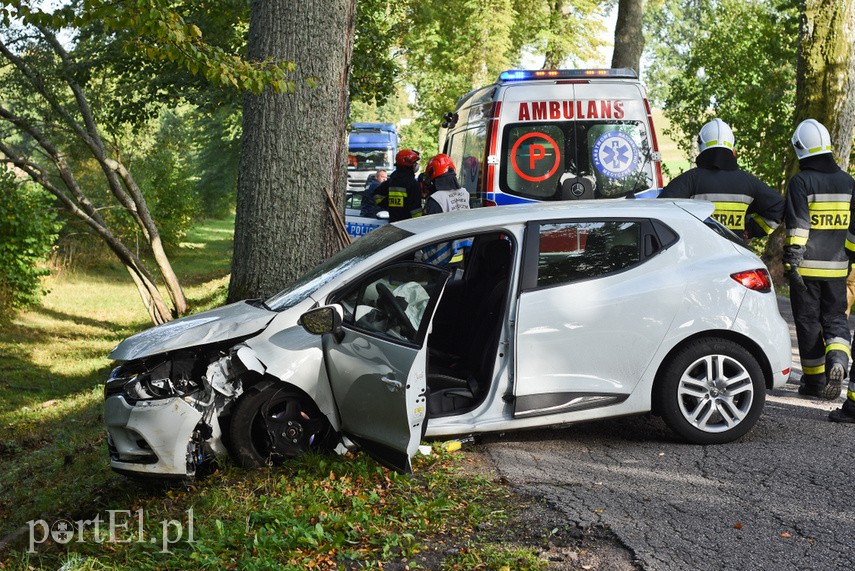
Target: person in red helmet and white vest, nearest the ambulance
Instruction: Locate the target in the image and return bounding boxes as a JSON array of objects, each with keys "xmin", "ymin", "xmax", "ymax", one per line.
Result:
[{"xmin": 416, "ymin": 153, "xmax": 472, "ymax": 266}]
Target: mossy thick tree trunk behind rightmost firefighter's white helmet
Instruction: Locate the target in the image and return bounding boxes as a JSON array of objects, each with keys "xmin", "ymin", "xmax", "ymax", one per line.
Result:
[{"xmin": 794, "ymin": 0, "xmax": 855, "ymax": 169}]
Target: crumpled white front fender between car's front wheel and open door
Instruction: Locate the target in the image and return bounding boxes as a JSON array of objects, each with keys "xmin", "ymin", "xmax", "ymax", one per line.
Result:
[{"xmin": 241, "ymin": 325, "xmax": 341, "ymax": 431}]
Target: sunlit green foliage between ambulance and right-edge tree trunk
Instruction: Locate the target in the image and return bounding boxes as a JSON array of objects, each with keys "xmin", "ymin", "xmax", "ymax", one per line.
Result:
[{"xmin": 647, "ymin": 0, "xmax": 798, "ymax": 188}]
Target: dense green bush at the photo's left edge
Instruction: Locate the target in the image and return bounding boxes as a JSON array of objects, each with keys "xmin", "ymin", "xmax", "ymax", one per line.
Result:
[{"xmin": 0, "ymin": 169, "xmax": 59, "ymax": 315}]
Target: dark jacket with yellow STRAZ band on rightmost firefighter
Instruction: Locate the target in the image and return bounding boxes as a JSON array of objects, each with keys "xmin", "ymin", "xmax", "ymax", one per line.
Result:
[{"xmin": 784, "ymin": 154, "xmax": 855, "ymax": 279}]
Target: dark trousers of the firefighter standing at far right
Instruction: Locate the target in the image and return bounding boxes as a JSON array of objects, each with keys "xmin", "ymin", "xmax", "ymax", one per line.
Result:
[{"xmin": 790, "ymin": 277, "xmax": 851, "ymax": 388}]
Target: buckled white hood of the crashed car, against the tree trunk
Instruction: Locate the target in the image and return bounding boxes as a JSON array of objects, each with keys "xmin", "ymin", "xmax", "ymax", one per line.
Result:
[{"xmin": 110, "ymin": 301, "xmax": 277, "ymax": 361}]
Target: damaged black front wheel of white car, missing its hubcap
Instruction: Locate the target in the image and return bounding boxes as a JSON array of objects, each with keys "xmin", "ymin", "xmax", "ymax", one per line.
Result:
[{"xmin": 229, "ymin": 382, "xmax": 336, "ymax": 468}]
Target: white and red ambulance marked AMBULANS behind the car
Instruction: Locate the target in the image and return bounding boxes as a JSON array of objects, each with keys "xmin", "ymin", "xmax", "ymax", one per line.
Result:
[{"xmin": 439, "ymin": 69, "xmax": 662, "ymax": 206}]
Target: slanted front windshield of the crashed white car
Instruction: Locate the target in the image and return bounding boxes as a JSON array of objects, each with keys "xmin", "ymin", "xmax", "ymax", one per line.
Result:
[{"xmin": 265, "ymin": 225, "xmax": 412, "ymax": 311}]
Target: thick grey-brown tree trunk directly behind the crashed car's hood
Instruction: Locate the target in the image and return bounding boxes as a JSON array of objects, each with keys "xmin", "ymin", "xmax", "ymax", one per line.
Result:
[{"xmin": 229, "ymin": 0, "xmax": 355, "ymax": 301}]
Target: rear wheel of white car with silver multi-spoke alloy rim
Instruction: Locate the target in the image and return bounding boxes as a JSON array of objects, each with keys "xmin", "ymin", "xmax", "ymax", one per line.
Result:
[{"xmin": 653, "ymin": 337, "xmax": 766, "ymax": 444}]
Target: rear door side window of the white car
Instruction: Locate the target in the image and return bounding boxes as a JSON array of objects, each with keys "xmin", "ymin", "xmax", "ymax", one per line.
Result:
[{"xmin": 536, "ymin": 220, "xmax": 642, "ymax": 287}]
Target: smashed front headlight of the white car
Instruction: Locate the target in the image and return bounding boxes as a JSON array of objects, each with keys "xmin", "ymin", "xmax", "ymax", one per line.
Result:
[{"xmin": 104, "ymin": 360, "xmax": 202, "ymax": 402}]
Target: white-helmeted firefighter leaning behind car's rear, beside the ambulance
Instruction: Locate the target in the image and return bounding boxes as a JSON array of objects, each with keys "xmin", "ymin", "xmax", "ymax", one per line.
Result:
[{"xmin": 659, "ymin": 119, "xmax": 784, "ymax": 241}]
